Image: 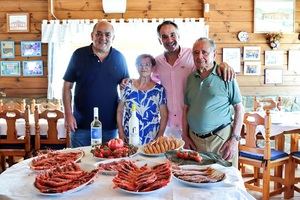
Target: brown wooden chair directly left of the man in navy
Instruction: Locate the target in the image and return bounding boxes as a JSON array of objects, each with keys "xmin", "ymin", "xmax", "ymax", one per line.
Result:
[{"xmin": 34, "ymin": 106, "xmax": 70, "ymax": 151}]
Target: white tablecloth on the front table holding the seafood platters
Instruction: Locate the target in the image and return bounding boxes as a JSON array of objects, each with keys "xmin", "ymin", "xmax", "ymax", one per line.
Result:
[{"xmin": 0, "ymin": 147, "xmax": 255, "ymax": 200}]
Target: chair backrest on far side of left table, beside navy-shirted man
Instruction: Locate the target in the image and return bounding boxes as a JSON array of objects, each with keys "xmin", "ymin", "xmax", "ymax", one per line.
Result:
[{"xmin": 30, "ymin": 99, "xmax": 62, "ymax": 113}]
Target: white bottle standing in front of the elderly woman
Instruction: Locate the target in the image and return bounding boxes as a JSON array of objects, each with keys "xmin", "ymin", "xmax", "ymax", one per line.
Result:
[{"xmin": 128, "ymin": 104, "xmax": 140, "ymax": 146}]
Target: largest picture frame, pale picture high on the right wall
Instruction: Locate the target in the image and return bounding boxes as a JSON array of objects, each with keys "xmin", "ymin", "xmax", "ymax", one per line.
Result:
[{"xmin": 254, "ymin": 0, "xmax": 295, "ymax": 33}]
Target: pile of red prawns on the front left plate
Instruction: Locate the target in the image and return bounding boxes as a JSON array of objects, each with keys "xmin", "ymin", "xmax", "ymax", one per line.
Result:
[{"xmin": 34, "ymin": 162, "xmax": 98, "ymax": 193}]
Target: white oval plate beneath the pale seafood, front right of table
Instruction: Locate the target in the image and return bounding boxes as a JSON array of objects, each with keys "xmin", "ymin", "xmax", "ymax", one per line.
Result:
[{"xmin": 172, "ymin": 165, "xmax": 226, "ymax": 187}]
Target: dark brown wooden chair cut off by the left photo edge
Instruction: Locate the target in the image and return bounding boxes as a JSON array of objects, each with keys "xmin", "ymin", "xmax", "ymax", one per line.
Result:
[{"xmin": 0, "ymin": 106, "xmax": 30, "ymax": 170}]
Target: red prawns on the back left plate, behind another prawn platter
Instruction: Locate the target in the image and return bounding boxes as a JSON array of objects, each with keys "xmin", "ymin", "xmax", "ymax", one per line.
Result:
[{"xmin": 30, "ymin": 151, "xmax": 83, "ymax": 171}]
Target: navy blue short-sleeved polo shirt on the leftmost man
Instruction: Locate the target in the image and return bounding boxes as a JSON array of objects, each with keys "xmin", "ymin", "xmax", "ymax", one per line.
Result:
[{"xmin": 63, "ymin": 45, "xmax": 129, "ymax": 130}]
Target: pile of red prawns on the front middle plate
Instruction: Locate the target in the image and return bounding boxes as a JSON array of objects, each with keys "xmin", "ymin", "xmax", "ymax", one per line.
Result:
[{"xmin": 113, "ymin": 162, "xmax": 171, "ymax": 192}]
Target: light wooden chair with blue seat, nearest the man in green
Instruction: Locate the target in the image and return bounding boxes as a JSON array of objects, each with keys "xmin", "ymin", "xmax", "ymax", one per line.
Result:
[{"xmin": 239, "ymin": 110, "xmax": 289, "ymax": 199}]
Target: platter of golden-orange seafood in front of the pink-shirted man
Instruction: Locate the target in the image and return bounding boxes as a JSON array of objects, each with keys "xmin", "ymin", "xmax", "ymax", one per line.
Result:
[{"xmin": 140, "ymin": 136, "xmax": 184, "ymax": 157}]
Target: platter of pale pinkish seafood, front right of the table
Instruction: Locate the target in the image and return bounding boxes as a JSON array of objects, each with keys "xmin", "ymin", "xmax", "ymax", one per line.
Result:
[{"xmin": 172, "ymin": 165, "xmax": 226, "ymax": 187}]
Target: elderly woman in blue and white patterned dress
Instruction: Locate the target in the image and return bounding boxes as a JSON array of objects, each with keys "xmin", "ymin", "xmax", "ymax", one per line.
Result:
[{"xmin": 117, "ymin": 54, "xmax": 168, "ymax": 144}]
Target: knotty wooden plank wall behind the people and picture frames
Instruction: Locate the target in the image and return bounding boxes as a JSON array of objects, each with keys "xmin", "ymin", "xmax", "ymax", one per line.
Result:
[{"xmin": 0, "ymin": 0, "xmax": 300, "ymax": 97}]
